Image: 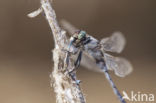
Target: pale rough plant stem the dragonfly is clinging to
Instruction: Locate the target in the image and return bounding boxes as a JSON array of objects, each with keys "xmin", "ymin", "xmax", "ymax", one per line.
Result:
[{"xmin": 28, "ymin": 0, "xmax": 85, "ymax": 103}]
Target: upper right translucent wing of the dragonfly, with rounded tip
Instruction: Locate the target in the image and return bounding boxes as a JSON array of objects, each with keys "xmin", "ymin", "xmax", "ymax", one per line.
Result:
[{"xmin": 100, "ymin": 32, "xmax": 126, "ymax": 53}]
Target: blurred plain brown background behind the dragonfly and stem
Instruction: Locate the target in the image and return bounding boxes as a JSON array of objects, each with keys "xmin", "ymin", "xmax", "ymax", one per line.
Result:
[{"xmin": 0, "ymin": 0, "xmax": 156, "ymax": 103}]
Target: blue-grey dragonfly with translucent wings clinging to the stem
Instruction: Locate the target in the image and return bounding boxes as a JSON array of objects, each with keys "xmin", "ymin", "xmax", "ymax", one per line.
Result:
[{"xmin": 61, "ymin": 20, "xmax": 133, "ymax": 103}]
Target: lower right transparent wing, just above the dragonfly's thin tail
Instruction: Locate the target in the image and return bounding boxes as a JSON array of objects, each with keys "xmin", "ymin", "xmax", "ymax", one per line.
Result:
[{"xmin": 104, "ymin": 53, "xmax": 133, "ymax": 77}]
